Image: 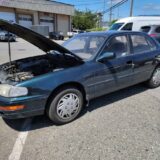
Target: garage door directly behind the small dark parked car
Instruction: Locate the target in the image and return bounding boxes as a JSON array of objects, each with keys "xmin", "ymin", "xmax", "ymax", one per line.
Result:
[{"xmin": 40, "ymin": 16, "xmax": 54, "ymax": 32}]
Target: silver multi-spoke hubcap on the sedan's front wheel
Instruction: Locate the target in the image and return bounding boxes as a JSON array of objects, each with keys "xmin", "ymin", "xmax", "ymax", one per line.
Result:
[{"xmin": 57, "ymin": 93, "xmax": 80, "ymax": 119}]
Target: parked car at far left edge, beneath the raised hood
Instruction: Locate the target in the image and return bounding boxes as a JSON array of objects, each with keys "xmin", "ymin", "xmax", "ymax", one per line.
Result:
[{"xmin": 0, "ymin": 29, "xmax": 16, "ymax": 42}]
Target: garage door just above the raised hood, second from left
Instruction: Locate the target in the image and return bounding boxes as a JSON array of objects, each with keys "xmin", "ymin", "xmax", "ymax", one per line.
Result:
[{"xmin": 18, "ymin": 14, "xmax": 33, "ymax": 28}]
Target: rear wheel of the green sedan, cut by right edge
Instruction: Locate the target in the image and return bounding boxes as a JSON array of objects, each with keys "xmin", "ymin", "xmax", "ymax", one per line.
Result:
[{"xmin": 147, "ymin": 66, "xmax": 160, "ymax": 88}]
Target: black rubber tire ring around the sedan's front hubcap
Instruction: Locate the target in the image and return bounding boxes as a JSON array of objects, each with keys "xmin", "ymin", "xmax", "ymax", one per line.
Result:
[{"xmin": 48, "ymin": 88, "xmax": 83, "ymax": 124}]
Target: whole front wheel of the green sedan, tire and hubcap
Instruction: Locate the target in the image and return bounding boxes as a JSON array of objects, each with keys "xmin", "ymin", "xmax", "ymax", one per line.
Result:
[{"xmin": 47, "ymin": 87, "xmax": 84, "ymax": 125}]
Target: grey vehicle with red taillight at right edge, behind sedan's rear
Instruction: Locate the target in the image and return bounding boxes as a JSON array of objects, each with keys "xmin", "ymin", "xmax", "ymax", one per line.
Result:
[{"xmin": 140, "ymin": 25, "xmax": 160, "ymax": 42}]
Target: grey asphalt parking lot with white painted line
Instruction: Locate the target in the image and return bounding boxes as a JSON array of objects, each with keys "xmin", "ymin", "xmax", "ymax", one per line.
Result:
[{"xmin": 0, "ymin": 39, "xmax": 160, "ymax": 160}]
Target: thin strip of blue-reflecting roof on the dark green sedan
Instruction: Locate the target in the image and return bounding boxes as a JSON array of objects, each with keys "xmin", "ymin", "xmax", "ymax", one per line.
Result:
[{"xmin": 77, "ymin": 30, "xmax": 146, "ymax": 37}]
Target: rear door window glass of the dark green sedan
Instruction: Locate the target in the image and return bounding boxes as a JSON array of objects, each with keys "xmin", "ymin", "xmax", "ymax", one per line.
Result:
[{"xmin": 131, "ymin": 35, "xmax": 156, "ymax": 54}]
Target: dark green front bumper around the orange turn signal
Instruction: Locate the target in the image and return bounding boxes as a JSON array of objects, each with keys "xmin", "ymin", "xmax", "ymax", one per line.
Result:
[{"xmin": 0, "ymin": 95, "xmax": 47, "ymax": 119}]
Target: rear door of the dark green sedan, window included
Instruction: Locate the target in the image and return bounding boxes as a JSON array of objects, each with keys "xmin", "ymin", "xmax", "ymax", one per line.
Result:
[{"xmin": 130, "ymin": 34, "xmax": 157, "ymax": 83}]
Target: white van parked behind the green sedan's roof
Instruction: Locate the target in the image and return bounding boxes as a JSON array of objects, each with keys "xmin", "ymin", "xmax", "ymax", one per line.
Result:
[{"xmin": 110, "ymin": 16, "xmax": 160, "ymax": 31}]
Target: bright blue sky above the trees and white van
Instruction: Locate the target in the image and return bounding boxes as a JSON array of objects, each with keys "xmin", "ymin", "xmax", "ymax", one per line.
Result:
[{"xmin": 56, "ymin": 0, "xmax": 160, "ymax": 21}]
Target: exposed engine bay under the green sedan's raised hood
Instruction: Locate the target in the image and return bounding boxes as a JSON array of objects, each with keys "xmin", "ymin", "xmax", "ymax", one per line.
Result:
[{"xmin": 0, "ymin": 57, "xmax": 52, "ymax": 83}]
